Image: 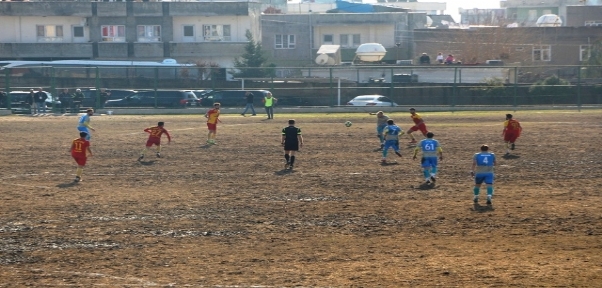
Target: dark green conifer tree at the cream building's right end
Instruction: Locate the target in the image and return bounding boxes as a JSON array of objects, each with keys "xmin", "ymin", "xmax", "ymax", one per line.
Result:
[{"xmin": 231, "ymin": 30, "xmax": 275, "ymax": 78}]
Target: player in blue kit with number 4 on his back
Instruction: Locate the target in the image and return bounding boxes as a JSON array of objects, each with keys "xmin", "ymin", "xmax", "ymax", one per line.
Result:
[{"xmin": 471, "ymin": 145, "xmax": 496, "ymax": 205}]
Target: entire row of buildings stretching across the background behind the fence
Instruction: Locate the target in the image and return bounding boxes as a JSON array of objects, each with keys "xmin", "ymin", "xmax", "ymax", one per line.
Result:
[{"xmin": 0, "ymin": 1, "xmax": 602, "ymax": 67}]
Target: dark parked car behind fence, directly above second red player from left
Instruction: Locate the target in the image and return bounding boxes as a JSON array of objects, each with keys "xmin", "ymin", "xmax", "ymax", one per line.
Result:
[{"xmin": 105, "ymin": 90, "xmax": 200, "ymax": 108}]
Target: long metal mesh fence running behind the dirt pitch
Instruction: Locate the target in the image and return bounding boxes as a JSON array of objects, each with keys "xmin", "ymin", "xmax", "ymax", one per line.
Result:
[{"xmin": 0, "ymin": 65, "xmax": 602, "ymax": 109}]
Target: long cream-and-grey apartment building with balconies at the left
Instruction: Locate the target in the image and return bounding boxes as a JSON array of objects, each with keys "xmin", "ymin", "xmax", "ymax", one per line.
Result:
[{"xmin": 0, "ymin": 1, "xmax": 261, "ymax": 67}]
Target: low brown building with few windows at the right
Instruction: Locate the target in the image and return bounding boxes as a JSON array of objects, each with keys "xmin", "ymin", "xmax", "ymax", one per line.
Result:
[{"xmin": 414, "ymin": 27, "xmax": 602, "ymax": 66}]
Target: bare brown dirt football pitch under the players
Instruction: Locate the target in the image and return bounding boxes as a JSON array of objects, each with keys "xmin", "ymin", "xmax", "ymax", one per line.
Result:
[{"xmin": 0, "ymin": 111, "xmax": 602, "ymax": 287}]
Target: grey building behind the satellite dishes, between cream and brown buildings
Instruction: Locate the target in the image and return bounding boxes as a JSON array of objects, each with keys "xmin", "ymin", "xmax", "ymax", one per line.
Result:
[{"xmin": 261, "ymin": 12, "xmax": 426, "ymax": 67}]
